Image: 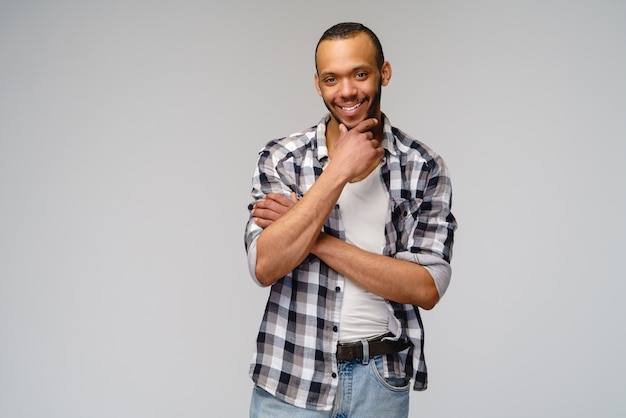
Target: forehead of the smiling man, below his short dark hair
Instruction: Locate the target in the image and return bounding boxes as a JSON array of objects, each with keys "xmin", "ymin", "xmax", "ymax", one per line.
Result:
[{"xmin": 315, "ymin": 33, "xmax": 376, "ymax": 73}]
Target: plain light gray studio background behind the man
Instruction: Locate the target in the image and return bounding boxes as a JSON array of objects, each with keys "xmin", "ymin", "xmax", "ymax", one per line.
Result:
[{"xmin": 0, "ymin": 0, "xmax": 626, "ymax": 418}]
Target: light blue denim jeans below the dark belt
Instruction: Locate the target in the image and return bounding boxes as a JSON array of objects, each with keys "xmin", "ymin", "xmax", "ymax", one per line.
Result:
[{"xmin": 250, "ymin": 356, "xmax": 410, "ymax": 418}]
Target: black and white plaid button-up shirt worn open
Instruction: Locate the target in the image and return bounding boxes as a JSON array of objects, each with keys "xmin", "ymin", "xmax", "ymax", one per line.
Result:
[{"xmin": 245, "ymin": 115, "xmax": 456, "ymax": 410}]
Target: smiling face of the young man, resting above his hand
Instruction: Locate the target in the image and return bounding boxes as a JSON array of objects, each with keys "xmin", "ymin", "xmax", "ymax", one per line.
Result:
[{"xmin": 315, "ymin": 33, "xmax": 391, "ymax": 129}]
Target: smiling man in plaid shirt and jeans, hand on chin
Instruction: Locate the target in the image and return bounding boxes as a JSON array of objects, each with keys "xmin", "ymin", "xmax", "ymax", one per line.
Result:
[{"xmin": 245, "ymin": 23, "xmax": 456, "ymax": 418}]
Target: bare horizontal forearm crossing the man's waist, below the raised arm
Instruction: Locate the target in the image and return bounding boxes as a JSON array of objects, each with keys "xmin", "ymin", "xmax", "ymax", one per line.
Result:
[{"xmin": 311, "ymin": 234, "xmax": 439, "ymax": 309}]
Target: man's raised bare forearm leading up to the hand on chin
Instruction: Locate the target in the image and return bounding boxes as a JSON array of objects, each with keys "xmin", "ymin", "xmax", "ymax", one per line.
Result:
[{"xmin": 253, "ymin": 170, "xmax": 347, "ymax": 285}]
